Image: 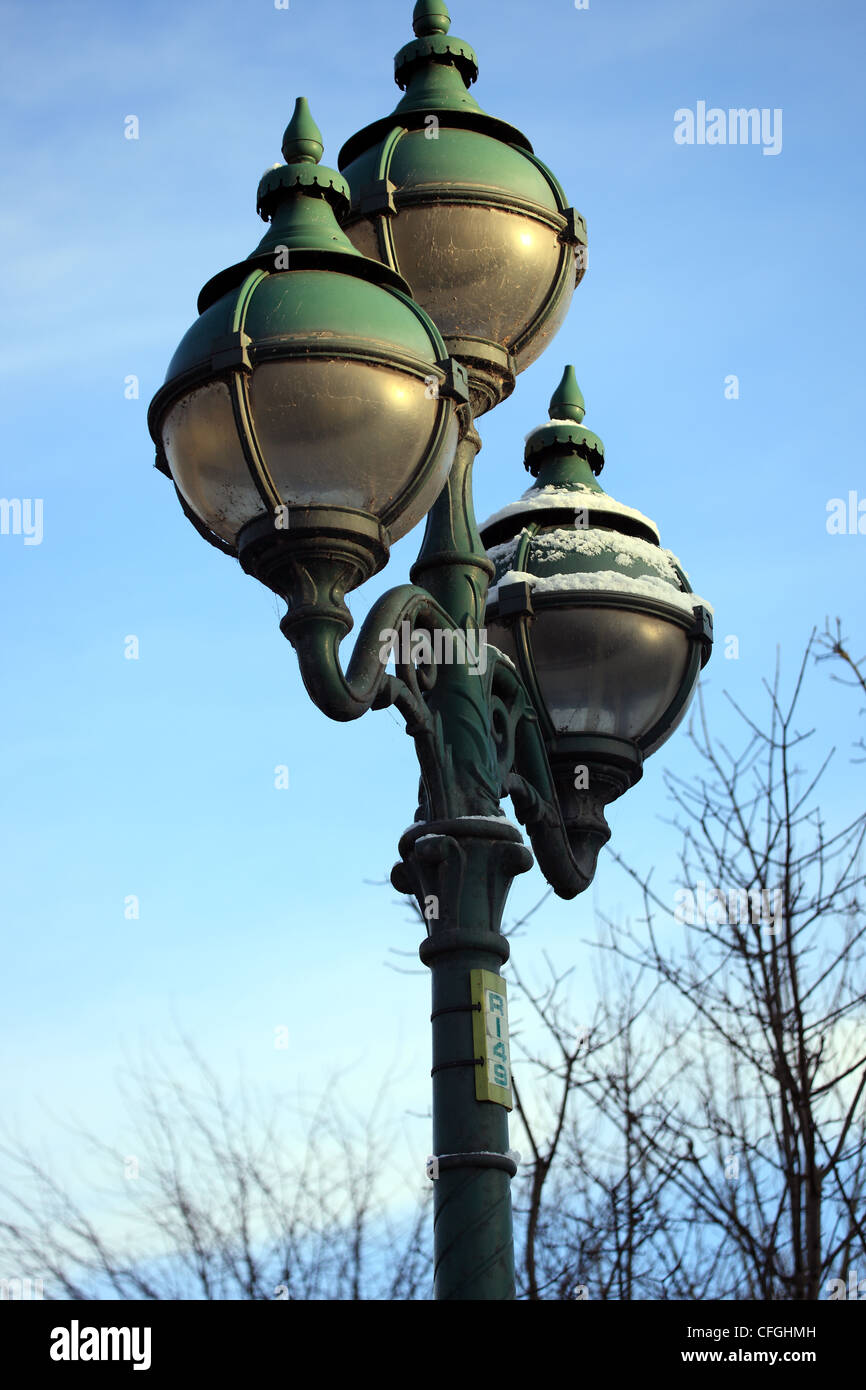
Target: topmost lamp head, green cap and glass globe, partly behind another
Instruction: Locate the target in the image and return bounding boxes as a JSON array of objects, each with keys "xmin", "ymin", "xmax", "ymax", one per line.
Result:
[{"xmin": 339, "ymin": 0, "xmax": 587, "ymax": 414}]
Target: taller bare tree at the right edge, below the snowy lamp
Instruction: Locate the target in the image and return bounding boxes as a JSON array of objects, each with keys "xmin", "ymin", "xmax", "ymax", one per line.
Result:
[{"xmin": 594, "ymin": 627, "xmax": 866, "ymax": 1300}]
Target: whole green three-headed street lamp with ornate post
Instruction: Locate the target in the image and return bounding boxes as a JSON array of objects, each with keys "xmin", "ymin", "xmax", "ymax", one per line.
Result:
[{"xmin": 149, "ymin": 0, "xmax": 710, "ymax": 1300}]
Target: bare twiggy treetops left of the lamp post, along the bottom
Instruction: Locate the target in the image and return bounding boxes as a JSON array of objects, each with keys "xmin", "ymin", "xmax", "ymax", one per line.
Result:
[{"xmin": 0, "ymin": 1044, "xmax": 431, "ymax": 1300}]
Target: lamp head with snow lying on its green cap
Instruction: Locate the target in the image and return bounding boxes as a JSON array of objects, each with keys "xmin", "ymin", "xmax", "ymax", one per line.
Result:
[{"xmin": 481, "ymin": 367, "xmax": 713, "ymax": 866}]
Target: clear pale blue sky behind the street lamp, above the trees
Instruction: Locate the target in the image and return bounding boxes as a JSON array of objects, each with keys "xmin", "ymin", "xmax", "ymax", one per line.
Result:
[{"xmin": 0, "ymin": 0, "xmax": 866, "ymax": 1200}]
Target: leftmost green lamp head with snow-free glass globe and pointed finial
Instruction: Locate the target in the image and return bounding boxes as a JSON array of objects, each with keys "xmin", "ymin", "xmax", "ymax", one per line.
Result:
[{"xmin": 149, "ymin": 97, "xmax": 466, "ymax": 587}]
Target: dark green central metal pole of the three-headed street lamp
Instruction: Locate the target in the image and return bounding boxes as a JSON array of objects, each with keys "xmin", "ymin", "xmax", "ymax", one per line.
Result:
[{"xmin": 392, "ymin": 406, "xmax": 532, "ymax": 1300}]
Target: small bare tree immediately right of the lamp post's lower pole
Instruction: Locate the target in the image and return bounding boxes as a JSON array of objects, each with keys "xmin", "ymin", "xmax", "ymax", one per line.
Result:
[{"xmin": 514, "ymin": 955, "xmax": 712, "ymax": 1301}]
